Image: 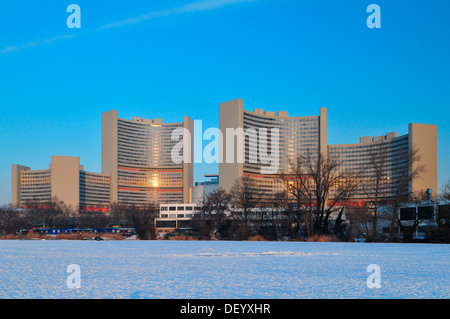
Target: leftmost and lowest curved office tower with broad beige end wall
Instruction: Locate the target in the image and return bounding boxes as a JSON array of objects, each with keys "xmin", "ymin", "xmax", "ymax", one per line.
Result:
[{"xmin": 12, "ymin": 156, "xmax": 110, "ymax": 212}]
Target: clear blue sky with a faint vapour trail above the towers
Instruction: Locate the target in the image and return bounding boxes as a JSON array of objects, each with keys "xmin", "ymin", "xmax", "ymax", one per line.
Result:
[{"xmin": 0, "ymin": 0, "xmax": 450, "ymax": 205}]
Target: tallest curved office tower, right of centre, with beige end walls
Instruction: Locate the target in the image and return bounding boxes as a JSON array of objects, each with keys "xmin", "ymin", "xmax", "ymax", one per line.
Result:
[{"xmin": 219, "ymin": 99, "xmax": 327, "ymax": 196}]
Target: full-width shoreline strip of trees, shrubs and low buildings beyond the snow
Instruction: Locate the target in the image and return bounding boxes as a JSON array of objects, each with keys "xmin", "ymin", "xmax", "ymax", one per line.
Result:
[{"xmin": 0, "ymin": 179, "xmax": 450, "ymax": 243}]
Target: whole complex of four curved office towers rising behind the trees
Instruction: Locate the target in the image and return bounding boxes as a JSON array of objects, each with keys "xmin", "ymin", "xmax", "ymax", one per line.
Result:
[{"xmin": 12, "ymin": 99, "xmax": 437, "ymax": 211}]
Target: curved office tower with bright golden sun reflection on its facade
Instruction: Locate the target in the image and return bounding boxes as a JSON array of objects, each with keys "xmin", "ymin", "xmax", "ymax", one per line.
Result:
[{"xmin": 102, "ymin": 110, "xmax": 193, "ymax": 205}]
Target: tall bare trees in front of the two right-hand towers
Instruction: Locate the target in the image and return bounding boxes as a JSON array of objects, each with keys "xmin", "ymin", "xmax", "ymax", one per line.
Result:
[{"xmin": 193, "ymin": 147, "xmax": 450, "ymax": 242}]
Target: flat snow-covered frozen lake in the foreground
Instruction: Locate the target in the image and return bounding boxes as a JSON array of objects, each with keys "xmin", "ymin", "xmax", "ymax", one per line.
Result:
[{"xmin": 0, "ymin": 240, "xmax": 450, "ymax": 299}]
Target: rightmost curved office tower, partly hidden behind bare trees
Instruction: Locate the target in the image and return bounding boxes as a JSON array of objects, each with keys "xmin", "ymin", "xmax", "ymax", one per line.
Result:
[{"xmin": 328, "ymin": 123, "xmax": 437, "ymax": 202}]
